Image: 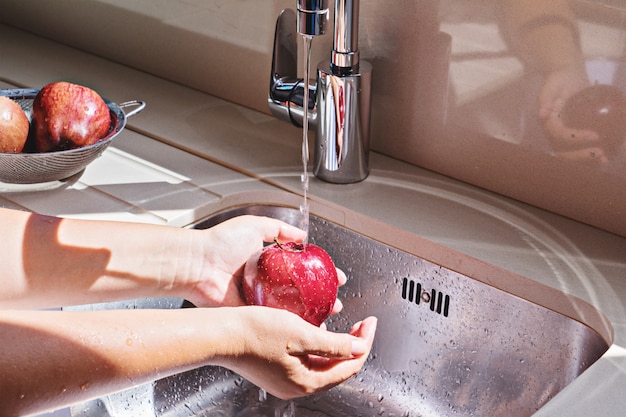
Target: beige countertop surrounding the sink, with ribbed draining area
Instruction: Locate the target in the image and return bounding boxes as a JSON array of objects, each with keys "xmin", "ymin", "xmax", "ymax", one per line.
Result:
[{"xmin": 0, "ymin": 26, "xmax": 626, "ymax": 416}]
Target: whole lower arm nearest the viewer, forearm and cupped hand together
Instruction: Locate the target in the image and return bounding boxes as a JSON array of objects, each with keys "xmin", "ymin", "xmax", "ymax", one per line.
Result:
[{"xmin": 0, "ymin": 306, "xmax": 376, "ymax": 415}]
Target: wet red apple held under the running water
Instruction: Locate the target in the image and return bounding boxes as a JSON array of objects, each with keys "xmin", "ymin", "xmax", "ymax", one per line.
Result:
[{"xmin": 243, "ymin": 242, "xmax": 339, "ymax": 326}]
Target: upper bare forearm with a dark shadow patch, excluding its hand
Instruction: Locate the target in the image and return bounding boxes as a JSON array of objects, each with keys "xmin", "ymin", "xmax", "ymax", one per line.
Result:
[{"xmin": 0, "ymin": 209, "xmax": 196, "ymax": 308}]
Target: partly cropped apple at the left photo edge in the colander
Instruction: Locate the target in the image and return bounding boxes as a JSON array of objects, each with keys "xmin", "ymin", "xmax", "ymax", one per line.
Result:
[{"xmin": 0, "ymin": 96, "xmax": 29, "ymax": 153}]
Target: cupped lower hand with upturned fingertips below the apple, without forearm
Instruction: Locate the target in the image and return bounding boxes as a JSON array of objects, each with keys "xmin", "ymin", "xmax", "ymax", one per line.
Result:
[{"xmin": 220, "ymin": 307, "xmax": 377, "ymax": 399}]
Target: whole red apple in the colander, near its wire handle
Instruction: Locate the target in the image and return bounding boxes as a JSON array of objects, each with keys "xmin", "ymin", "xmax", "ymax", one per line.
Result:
[{"xmin": 32, "ymin": 82, "xmax": 111, "ymax": 152}]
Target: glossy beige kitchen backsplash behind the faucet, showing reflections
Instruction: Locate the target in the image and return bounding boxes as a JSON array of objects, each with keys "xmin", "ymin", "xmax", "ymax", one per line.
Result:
[{"xmin": 0, "ymin": 0, "xmax": 626, "ymax": 236}]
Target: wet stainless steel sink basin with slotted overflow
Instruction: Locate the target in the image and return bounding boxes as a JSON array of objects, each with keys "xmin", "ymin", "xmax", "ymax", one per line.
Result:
[{"xmin": 72, "ymin": 205, "xmax": 612, "ymax": 417}]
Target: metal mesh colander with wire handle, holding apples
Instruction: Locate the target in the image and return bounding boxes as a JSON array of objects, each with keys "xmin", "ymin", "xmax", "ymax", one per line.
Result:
[{"xmin": 0, "ymin": 88, "xmax": 146, "ymax": 184}]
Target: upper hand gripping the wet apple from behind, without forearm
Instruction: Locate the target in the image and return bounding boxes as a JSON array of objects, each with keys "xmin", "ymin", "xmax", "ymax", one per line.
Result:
[{"xmin": 185, "ymin": 216, "xmax": 346, "ymax": 313}]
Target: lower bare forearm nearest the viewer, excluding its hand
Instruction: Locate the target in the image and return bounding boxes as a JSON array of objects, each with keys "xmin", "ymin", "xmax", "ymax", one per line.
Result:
[{"xmin": 0, "ymin": 309, "xmax": 234, "ymax": 415}]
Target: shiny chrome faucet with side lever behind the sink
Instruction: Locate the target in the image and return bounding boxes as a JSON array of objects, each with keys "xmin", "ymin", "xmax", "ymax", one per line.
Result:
[{"xmin": 268, "ymin": 0, "xmax": 372, "ymax": 183}]
